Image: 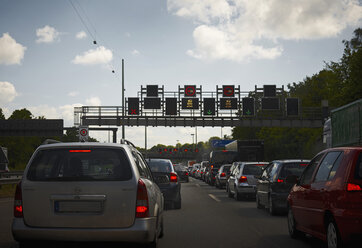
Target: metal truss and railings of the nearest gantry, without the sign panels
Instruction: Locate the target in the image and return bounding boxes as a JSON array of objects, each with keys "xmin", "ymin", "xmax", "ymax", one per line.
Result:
[{"xmin": 74, "ymin": 86, "xmax": 323, "ymax": 127}]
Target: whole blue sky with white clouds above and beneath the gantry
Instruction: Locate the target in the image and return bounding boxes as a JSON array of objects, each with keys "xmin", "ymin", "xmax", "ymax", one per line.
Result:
[{"xmin": 0, "ymin": 0, "xmax": 362, "ymax": 148}]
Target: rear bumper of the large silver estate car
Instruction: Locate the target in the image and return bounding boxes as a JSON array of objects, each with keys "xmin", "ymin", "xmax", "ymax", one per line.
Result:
[{"xmin": 12, "ymin": 217, "xmax": 156, "ymax": 243}]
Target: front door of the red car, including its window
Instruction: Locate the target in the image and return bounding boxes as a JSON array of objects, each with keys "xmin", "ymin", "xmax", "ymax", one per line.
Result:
[{"xmin": 292, "ymin": 153, "xmax": 324, "ymax": 232}]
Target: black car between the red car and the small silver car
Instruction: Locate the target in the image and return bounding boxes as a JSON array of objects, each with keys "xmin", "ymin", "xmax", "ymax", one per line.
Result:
[{"xmin": 256, "ymin": 159, "xmax": 309, "ymax": 215}]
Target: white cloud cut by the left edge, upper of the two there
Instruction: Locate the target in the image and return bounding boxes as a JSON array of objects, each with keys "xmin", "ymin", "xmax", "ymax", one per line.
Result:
[{"xmin": 0, "ymin": 33, "xmax": 26, "ymax": 65}]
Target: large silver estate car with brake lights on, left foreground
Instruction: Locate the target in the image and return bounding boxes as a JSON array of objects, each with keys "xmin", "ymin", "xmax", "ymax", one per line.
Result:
[{"xmin": 12, "ymin": 141, "xmax": 166, "ymax": 246}]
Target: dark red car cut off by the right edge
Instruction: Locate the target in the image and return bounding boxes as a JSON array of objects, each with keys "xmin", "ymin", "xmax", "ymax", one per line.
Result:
[{"xmin": 287, "ymin": 147, "xmax": 362, "ymax": 248}]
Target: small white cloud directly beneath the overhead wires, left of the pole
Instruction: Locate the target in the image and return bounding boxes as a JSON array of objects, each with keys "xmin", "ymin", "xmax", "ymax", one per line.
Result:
[{"xmin": 72, "ymin": 46, "xmax": 113, "ymax": 65}]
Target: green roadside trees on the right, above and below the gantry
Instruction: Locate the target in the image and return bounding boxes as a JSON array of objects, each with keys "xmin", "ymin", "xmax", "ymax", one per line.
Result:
[{"xmin": 232, "ymin": 28, "xmax": 362, "ymax": 160}]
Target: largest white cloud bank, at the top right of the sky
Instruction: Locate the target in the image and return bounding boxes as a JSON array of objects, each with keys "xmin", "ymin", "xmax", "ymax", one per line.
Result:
[{"xmin": 167, "ymin": 0, "xmax": 362, "ymax": 61}]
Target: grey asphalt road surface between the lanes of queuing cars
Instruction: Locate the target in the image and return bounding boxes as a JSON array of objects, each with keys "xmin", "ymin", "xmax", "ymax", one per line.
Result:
[{"xmin": 0, "ymin": 179, "xmax": 326, "ymax": 248}]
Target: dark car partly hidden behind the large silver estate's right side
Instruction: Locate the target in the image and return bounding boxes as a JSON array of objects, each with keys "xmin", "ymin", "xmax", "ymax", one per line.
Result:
[{"xmin": 147, "ymin": 158, "xmax": 181, "ymax": 209}]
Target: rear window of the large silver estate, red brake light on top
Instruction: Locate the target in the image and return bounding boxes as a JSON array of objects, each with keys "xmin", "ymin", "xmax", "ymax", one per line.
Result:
[{"xmin": 27, "ymin": 147, "xmax": 132, "ymax": 181}]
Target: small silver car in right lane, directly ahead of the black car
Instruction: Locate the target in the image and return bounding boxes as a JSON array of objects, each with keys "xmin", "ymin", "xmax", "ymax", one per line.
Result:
[{"xmin": 227, "ymin": 162, "xmax": 268, "ymax": 201}]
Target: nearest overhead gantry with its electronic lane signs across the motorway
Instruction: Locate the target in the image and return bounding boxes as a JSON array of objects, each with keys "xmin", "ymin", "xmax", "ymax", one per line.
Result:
[{"xmin": 75, "ymin": 84, "xmax": 323, "ymax": 127}]
